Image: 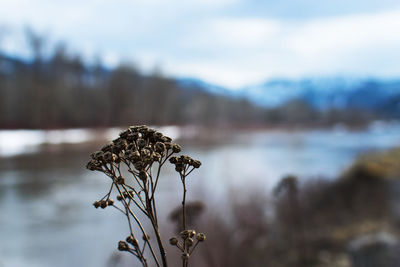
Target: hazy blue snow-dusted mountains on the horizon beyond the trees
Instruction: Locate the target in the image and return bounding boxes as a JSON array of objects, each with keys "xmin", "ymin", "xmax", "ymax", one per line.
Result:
[{"xmin": 180, "ymin": 77, "xmax": 400, "ymax": 117}]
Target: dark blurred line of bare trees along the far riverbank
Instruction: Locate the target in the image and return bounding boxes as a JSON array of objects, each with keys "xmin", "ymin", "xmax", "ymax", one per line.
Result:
[{"xmin": 0, "ymin": 31, "xmax": 380, "ymax": 129}]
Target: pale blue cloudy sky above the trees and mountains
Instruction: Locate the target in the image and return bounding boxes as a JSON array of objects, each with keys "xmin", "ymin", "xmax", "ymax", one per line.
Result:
[{"xmin": 0, "ymin": 0, "xmax": 400, "ymax": 89}]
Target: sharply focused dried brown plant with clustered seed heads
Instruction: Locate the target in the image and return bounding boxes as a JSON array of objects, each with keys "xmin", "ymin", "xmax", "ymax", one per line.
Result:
[{"xmin": 86, "ymin": 126, "xmax": 206, "ymax": 267}]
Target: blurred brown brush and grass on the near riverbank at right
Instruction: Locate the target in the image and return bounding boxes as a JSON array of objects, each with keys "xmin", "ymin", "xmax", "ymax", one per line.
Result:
[{"xmin": 180, "ymin": 149, "xmax": 400, "ymax": 267}]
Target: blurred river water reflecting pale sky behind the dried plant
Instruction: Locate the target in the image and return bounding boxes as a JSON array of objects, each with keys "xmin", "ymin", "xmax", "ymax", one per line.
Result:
[{"xmin": 0, "ymin": 126, "xmax": 400, "ymax": 267}]
